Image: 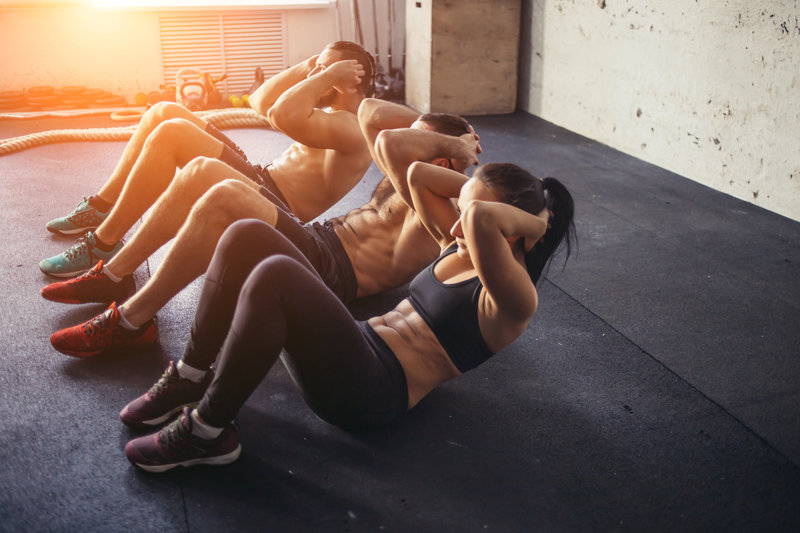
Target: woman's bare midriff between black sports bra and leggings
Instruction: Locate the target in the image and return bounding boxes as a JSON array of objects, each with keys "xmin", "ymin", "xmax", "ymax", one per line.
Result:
[{"xmin": 368, "ymin": 300, "xmax": 461, "ymax": 409}]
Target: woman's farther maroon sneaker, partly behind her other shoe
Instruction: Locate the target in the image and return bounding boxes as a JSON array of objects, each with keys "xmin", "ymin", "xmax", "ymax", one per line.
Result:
[{"xmin": 119, "ymin": 361, "xmax": 214, "ymax": 428}]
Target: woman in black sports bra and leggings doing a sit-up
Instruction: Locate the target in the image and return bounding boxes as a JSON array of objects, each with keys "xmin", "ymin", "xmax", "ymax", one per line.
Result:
[{"xmin": 123, "ymin": 163, "xmax": 574, "ymax": 472}]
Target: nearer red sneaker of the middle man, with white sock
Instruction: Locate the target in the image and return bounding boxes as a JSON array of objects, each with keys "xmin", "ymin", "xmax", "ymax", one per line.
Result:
[{"xmin": 50, "ymin": 302, "xmax": 157, "ymax": 357}]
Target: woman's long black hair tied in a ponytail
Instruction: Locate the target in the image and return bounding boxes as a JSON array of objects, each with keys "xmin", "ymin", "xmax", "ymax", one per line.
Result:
[{"xmin": 474, "ymin": 163, "xmax": 578, "ymax": 283}]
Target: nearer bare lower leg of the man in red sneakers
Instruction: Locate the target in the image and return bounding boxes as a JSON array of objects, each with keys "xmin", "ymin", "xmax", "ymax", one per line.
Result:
[{"xmin": 120, "ymin": 180, "xmax": 278, "ymax": 326}]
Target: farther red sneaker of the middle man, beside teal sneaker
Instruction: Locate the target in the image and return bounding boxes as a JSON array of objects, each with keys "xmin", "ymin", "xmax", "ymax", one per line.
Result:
[{"xmin": 41, "ymin": 259, "xmax": 136, "ymax": 304}]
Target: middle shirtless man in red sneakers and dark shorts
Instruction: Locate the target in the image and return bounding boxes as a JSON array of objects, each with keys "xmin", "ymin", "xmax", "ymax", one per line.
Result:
[{"xmin": 47, "ymin": 99, "xmax": 480, "ymax": 357}]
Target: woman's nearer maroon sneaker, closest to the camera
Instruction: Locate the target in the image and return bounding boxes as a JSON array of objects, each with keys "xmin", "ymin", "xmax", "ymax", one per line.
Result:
[{"xmin": 125, "ymin": 407, "xmax": 242, "ymax": 472}]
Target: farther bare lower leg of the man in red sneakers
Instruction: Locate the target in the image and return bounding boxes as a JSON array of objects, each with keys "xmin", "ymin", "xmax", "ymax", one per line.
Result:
[{"xmin": 106, "ymin": 157, "xmax": 258, "ymax": 277}]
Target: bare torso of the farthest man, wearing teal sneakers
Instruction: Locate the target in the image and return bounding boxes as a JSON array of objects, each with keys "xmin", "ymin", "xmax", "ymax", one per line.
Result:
[{"xmin": 269, "ymin": 111, "xmax": 372, "ymax": 222}]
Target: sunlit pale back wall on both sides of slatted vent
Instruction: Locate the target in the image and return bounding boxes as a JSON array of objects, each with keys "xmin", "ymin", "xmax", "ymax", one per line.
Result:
[{"xmin": 0, "ymin": 4, "xmax": 339, "ymax": 103}]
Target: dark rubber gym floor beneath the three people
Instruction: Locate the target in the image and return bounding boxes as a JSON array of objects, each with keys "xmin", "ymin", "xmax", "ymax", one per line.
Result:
[{"xmin": 0, "ymin": 113, "xmax": 800, "ymax": 532}]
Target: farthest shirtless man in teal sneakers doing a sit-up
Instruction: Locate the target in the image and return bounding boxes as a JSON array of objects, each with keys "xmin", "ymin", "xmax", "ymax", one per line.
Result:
[{"xmin": 39, "ymin": 41, "xmax": 374, "ymax": 281}]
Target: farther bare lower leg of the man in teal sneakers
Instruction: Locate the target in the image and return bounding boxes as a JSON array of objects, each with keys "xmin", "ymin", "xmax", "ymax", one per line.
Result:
[{"xmin": 97, "ymin": 102, "xmax": 206, "ymax": 204}]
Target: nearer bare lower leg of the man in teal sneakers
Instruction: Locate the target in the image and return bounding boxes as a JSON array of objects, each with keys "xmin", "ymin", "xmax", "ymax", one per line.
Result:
[{"xmin": 95, "ymin": 119, "xmax": 224, "ymax": 244}]
